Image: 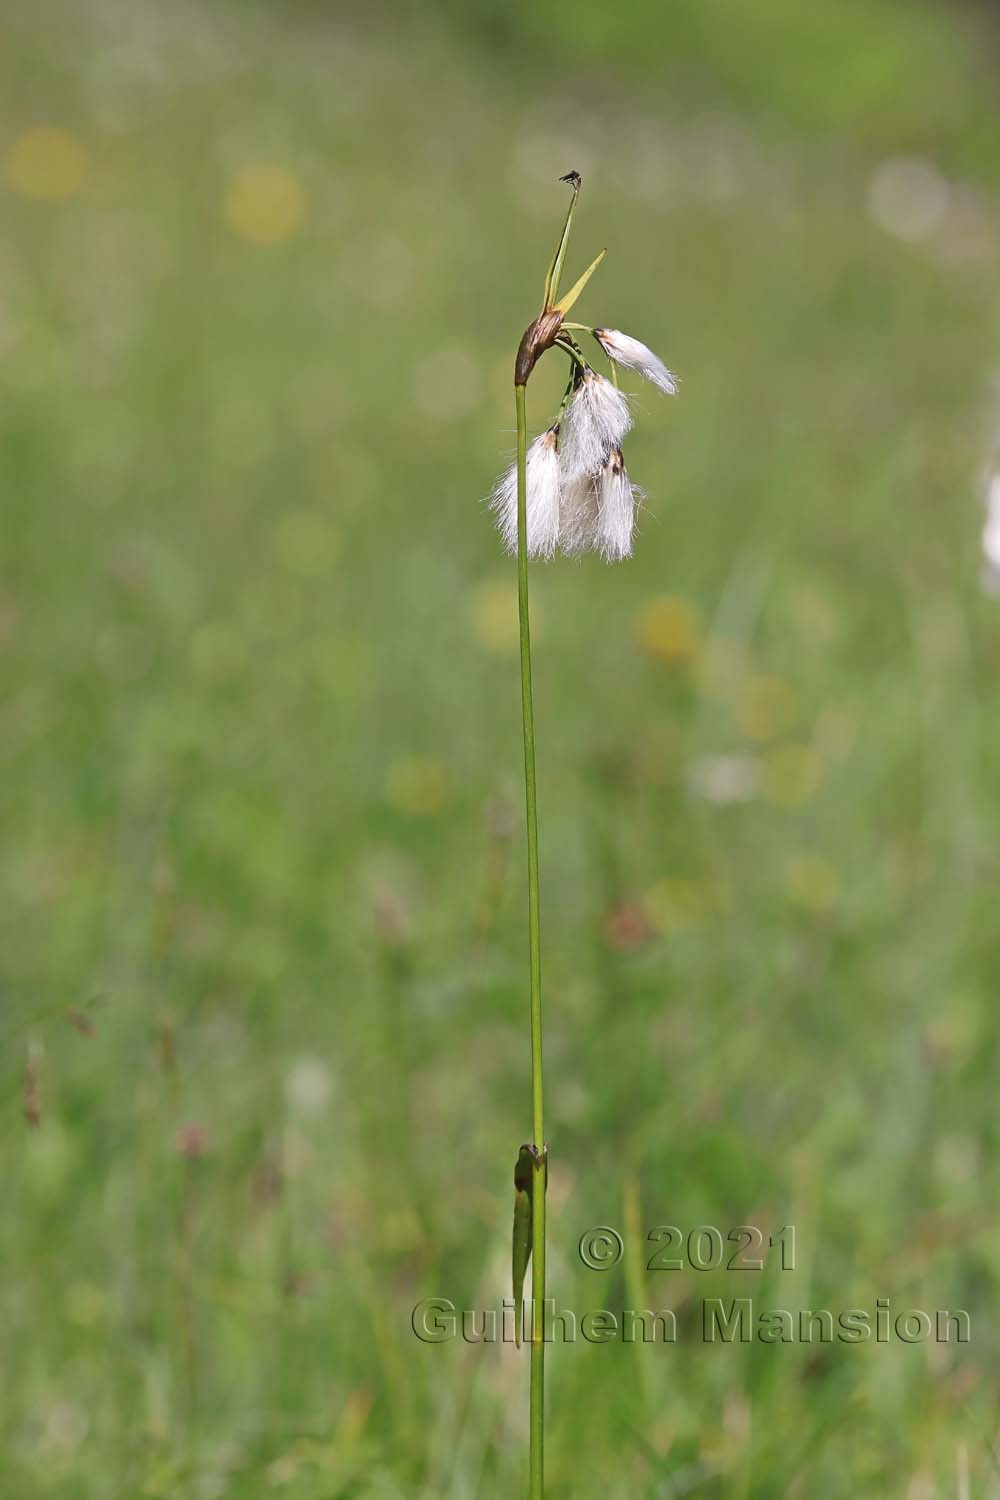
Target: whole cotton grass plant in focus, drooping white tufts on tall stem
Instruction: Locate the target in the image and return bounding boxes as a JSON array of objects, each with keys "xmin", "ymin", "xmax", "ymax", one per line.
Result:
[{"xmin": 490, "ymin": 173, "xmax": 676, "ymax": 1500}]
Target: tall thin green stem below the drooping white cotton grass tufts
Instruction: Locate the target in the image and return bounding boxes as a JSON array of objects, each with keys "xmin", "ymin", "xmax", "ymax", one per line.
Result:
[{"xmin": 514, "ymin": 386, "xmax": 547, "ymax": 1500}]
